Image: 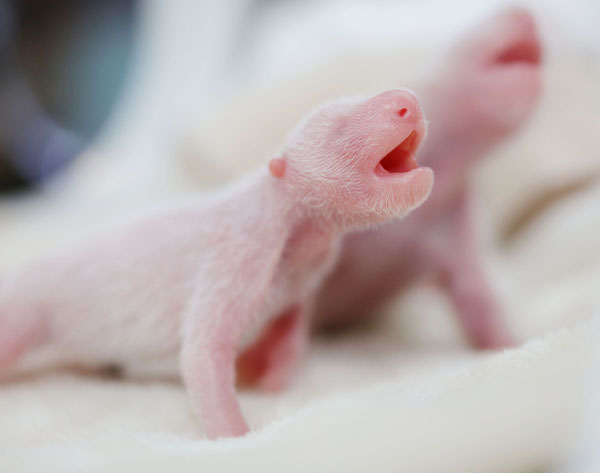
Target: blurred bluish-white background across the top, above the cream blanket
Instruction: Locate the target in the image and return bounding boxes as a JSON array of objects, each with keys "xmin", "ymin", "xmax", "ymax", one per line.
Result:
[{"xmin": 98, "ymin": 0, "xmax": 600, "ymax": 186}]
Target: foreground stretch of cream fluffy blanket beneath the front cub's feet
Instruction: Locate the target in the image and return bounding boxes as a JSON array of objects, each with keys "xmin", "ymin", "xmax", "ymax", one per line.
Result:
[{"xmin": 0, "ymin": 322, "xmax": 600, "ymax": 473}]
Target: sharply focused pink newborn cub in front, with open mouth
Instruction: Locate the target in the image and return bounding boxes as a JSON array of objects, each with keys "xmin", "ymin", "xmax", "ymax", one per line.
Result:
[{"xmin": 0, "ymin": 90, "xmax": 433, "ymax": 438}]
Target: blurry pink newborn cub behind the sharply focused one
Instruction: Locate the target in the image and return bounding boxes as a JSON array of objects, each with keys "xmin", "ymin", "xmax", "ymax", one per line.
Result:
[{"xmin": 316, "ymin": 9, "xmax": 541, "ymax": 348}]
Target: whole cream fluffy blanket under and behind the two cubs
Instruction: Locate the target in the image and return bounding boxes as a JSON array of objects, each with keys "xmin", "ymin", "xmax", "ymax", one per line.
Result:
[{"xmin": 0, "ymin": 0, "xmax": 600, "ymax": 473}]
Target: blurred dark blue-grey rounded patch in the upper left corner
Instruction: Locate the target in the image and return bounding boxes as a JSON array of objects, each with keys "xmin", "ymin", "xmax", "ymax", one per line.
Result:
[{"xmin": 0, "ymin": 0, "xmax": 137, "ymax": 193}]
